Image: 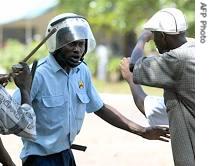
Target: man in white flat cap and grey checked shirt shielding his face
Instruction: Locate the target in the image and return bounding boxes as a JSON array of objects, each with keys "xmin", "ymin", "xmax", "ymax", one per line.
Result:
[{"xmin": 129, "ymin": 8, "xmax": 195, "ymax": 166}]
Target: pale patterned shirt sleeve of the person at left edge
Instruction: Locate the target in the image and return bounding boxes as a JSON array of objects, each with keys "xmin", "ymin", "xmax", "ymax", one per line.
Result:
[{"xmin": 0, "ymin": 85, "xmax": 36, "ymax": 139}]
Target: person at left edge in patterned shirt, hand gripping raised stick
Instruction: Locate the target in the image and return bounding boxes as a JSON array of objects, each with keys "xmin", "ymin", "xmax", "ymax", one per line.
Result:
[{"xmin": 0, "ymin": 63, "xmax": 36, "ymax": 166}]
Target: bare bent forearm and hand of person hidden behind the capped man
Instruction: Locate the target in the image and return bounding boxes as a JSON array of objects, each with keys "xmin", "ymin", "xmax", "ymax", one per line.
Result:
[{"xmin": 120, "ymin": 58, "xmax": 147, "ymax": 116}]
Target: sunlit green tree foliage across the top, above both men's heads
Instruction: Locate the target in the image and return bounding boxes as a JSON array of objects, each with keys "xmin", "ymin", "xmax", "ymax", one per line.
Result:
[{"xmin": 60, "ymin": 0, "xmax": 195, "ymax": 37}]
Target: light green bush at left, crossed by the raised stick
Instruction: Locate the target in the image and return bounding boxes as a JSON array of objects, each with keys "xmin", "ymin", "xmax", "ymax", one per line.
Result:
[{"xmin": 0, "ymin": 40, "xmax": 48, "ymax": 72}]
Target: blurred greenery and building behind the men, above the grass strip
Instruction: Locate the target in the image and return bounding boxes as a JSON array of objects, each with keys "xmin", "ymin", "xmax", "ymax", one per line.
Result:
[{"xmin": 0, "ymin": 0, "xmax": 195, "ymax": 89}]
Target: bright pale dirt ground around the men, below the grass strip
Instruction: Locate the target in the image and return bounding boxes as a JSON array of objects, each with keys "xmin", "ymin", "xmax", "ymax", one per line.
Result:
[{"xmin": 1, "ymin": 94, "xmax": 174, "ymax": 166}]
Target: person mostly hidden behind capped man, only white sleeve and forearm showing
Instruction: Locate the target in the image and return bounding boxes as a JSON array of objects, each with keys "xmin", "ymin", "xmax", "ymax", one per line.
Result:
[{"xmin": 120, "ymin": 58, "xmax": 169, "ymax": 126}]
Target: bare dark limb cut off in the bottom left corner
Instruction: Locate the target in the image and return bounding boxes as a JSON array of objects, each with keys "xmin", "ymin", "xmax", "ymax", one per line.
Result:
[{"xmin": 0, "ymin": 138, "xmax": 15, "ymax": 166}]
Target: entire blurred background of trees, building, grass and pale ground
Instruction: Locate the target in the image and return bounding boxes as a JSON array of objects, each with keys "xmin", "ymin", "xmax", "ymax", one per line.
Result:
[{"xmin": 0, "ymin": 0, "xmax": 195, "ymax": 166}]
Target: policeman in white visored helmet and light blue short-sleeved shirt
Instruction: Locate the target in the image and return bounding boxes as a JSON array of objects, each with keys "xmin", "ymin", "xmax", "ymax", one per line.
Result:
[{"xmin": 14, "ymin": 13, "xmax": 168, "ymax": 166}]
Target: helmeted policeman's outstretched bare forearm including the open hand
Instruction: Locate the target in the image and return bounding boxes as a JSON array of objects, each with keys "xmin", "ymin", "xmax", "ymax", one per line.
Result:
[{"xmin": 95, "ymin": 104, "xmax": 169, "ymax": 142}]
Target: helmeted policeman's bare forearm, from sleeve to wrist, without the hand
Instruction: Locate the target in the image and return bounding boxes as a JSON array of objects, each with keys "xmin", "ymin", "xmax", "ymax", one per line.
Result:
[{"xmin": 95, "ymin": 104, "xmax": 145, "ymax": 135}]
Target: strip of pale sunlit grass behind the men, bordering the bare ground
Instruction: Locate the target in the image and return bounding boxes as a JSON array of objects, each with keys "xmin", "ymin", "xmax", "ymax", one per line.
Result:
[{"xmin": 93, "ymin": 78, "xmax": 163, "ymax": 96}]
